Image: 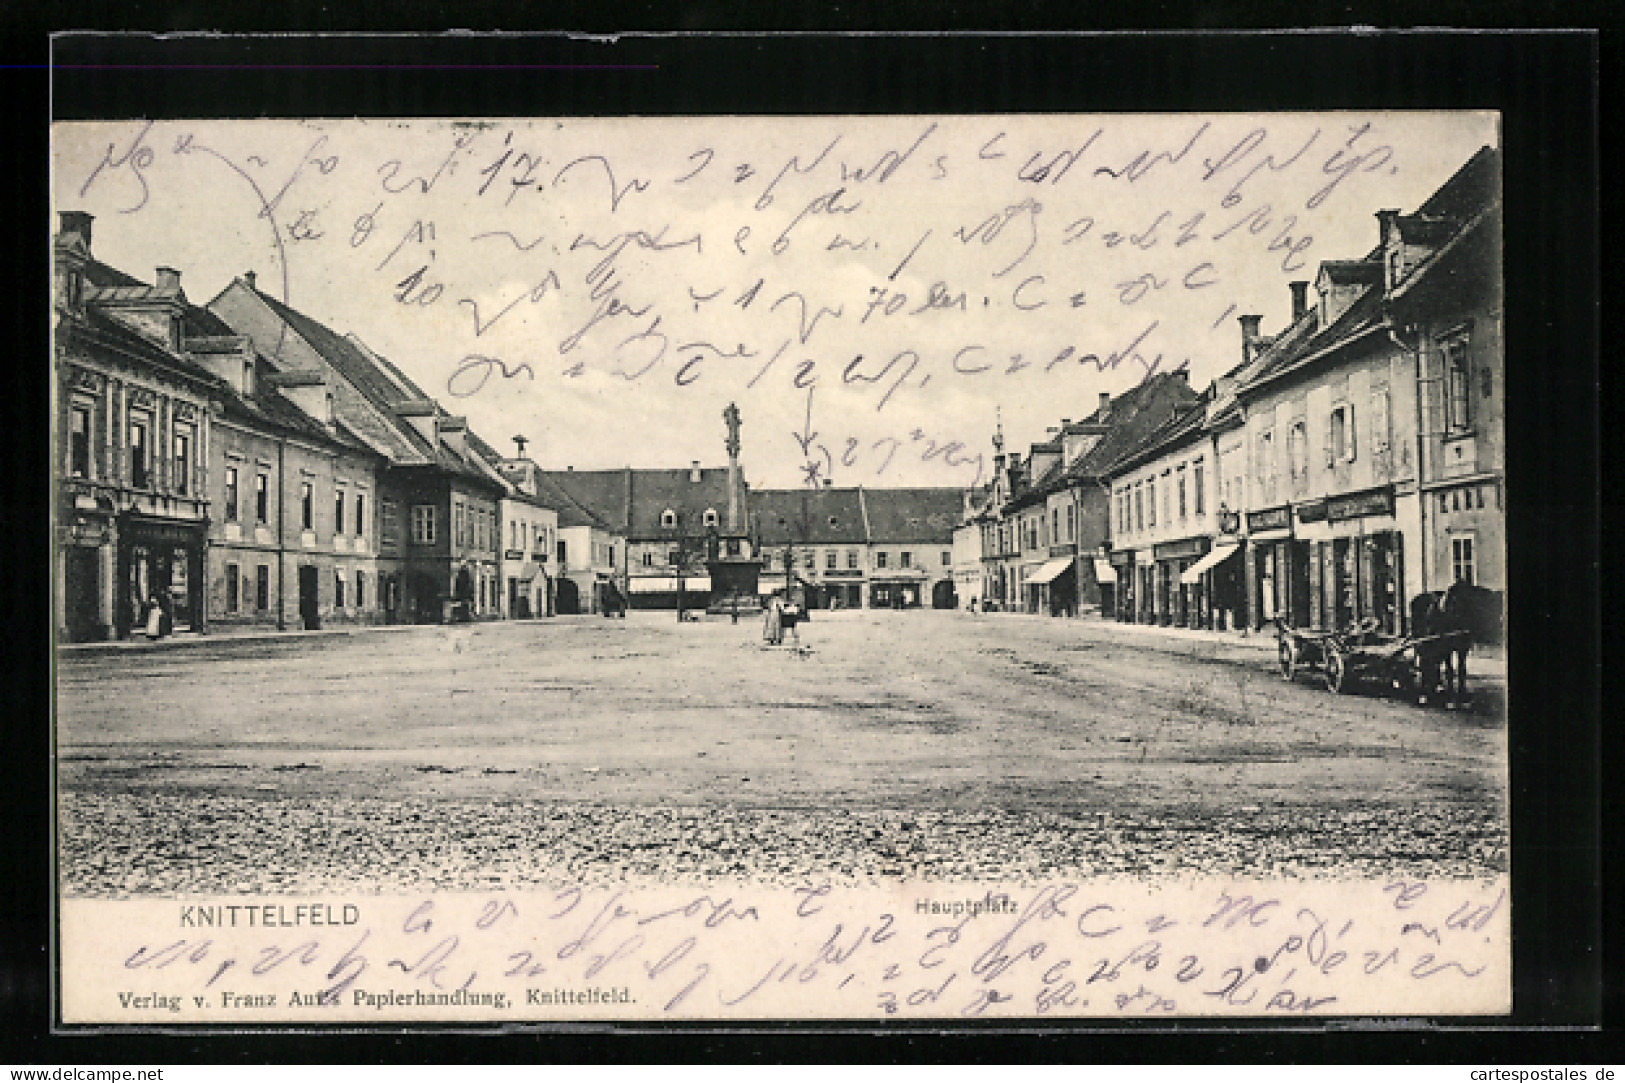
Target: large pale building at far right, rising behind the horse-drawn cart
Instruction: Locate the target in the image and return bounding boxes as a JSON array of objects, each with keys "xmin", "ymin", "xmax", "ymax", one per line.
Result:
[{"xmin": 1220, "ymin": 148, "xmax": 1505, "ymax": 633}]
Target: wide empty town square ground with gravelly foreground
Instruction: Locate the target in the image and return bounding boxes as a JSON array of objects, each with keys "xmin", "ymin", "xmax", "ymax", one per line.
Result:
[{"xmin": 57, "ymin": 611, "xmax": 1506, "ymax": 894}]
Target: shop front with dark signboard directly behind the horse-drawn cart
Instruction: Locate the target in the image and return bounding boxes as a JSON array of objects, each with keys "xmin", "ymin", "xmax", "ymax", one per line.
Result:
[{"xmin": 1295, "ymin": 485, "xmax": 1406, "ymax": 634}]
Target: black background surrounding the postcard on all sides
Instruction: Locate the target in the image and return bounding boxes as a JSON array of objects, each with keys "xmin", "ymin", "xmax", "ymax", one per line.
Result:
[{"xmin": 0, "ymin": 25, "xmax": 1605, "ymax": 1067}]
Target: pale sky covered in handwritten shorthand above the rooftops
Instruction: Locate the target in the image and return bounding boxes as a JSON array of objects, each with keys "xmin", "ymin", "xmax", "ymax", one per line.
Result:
[{"xmin": 52, "ymin": 112, "xmax": 1498, "ymax": 488}]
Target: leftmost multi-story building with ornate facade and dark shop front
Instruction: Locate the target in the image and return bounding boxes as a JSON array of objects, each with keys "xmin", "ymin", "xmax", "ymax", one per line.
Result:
[{"xmin": 54, "ymin": 211, "xmax": 219, "ymax": 641}]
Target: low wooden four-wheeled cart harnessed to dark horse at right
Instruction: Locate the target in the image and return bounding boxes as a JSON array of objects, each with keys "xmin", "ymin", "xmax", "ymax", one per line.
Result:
[{"xmin": 1276, "ymin": 620, "xmax": 1472, "ymax": 702}]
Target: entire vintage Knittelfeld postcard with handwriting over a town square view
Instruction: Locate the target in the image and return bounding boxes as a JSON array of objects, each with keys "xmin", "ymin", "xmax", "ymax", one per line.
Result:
[{"xmin": 50, "ymin": 112, "xmax": 1511, "ymax": 1028}]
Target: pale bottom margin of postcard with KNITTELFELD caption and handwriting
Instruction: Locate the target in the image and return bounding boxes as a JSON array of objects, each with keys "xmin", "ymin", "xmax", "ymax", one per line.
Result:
[{"xmin": 62, "ymin": 880, "xmax": 1510, "ymax": 1023}]
